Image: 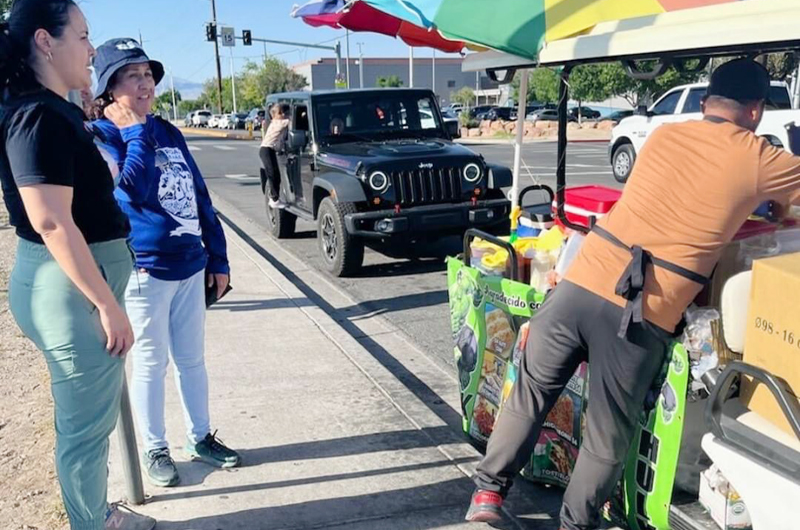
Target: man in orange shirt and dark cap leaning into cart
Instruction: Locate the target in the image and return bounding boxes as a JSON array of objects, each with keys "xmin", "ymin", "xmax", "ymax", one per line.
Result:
[{"xmin": 466, "ymin": 59, "xmax": 800, "ymax": 530}]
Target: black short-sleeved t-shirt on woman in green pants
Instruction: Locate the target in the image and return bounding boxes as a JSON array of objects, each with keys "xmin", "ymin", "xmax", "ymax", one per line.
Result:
[{"xmin": 0, "ymin": 89, "xmax": 130, "ymax": 244}]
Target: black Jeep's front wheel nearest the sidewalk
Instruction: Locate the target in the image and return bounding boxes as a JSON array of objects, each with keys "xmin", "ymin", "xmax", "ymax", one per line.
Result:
[{"xmin": 317, "ymin": 197, "xmax": 364, "ymax": 277}]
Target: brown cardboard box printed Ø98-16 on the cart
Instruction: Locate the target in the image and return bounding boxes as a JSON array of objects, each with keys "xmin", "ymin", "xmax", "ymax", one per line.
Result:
[{"xmin": 742, "ymin": 254, "xmax": 800, "ymax": 436}]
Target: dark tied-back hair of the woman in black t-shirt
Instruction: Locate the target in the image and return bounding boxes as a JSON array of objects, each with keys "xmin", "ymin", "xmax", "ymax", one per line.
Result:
[{"xmin": 0, "ymin": 0, "xmax": 77, "ymax": 95}]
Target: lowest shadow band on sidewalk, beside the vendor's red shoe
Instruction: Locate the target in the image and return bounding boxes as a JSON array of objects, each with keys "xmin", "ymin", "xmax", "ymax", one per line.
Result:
[{"xmin": 151, "ymin": 478, "xmax": 544, "ymax": 530}]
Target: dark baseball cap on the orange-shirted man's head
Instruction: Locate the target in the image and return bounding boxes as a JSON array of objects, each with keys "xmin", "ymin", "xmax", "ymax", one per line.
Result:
[{"xmin": 707, "ymin": 59, "xmax": 770, "ymax": 103}]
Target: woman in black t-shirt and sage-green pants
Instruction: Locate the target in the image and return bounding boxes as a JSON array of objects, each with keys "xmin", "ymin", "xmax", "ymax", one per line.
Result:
[{"xmin": 0, "ymin": 0, "xmax": 155, "ymax": 530}]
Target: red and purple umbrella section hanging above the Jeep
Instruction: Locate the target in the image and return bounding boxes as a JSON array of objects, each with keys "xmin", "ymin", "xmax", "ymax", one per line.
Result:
[{"xmin": 292, "ymin": 0, "xmax": 465, "ymax": 53}]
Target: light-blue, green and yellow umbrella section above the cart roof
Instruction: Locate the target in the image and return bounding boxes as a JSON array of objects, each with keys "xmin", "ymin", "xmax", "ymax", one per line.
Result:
[{"xmin": 361, "ymin": 0, "xmax": 743, "ymax": 59}]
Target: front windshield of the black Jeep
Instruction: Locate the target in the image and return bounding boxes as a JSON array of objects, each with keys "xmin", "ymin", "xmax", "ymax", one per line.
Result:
[{"xmin": 314, "ymin": 91, "xmax": 445, "ymax": 144}]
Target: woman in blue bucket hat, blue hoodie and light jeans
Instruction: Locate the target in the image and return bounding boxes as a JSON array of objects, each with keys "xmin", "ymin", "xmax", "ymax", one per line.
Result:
[{"xmin": 94, "ymin": 39, "xmax": 239, "ymax": 486}]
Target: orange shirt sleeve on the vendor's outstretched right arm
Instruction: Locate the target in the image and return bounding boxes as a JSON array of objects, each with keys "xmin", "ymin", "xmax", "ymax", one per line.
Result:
[{"xmin": 758, "ymin": 139, "xmax": 800, "ymax": 203}]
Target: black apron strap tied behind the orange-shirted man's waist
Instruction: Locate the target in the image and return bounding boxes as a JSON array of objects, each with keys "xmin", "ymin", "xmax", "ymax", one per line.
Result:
[{"xmin": 592, "ymin": 226, "xmax": 709, "ymax": 338}]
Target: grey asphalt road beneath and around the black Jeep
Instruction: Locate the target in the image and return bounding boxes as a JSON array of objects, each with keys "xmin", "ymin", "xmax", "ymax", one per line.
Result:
[{"xmin": 187, "ymin": 136, "xmax": 618, "ymax": 364}]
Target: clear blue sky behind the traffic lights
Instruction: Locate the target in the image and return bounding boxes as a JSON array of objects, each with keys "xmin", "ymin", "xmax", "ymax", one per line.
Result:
[{"xmin": 79, "ymin": 0, "xmax": 456, "ymax": 82}]
